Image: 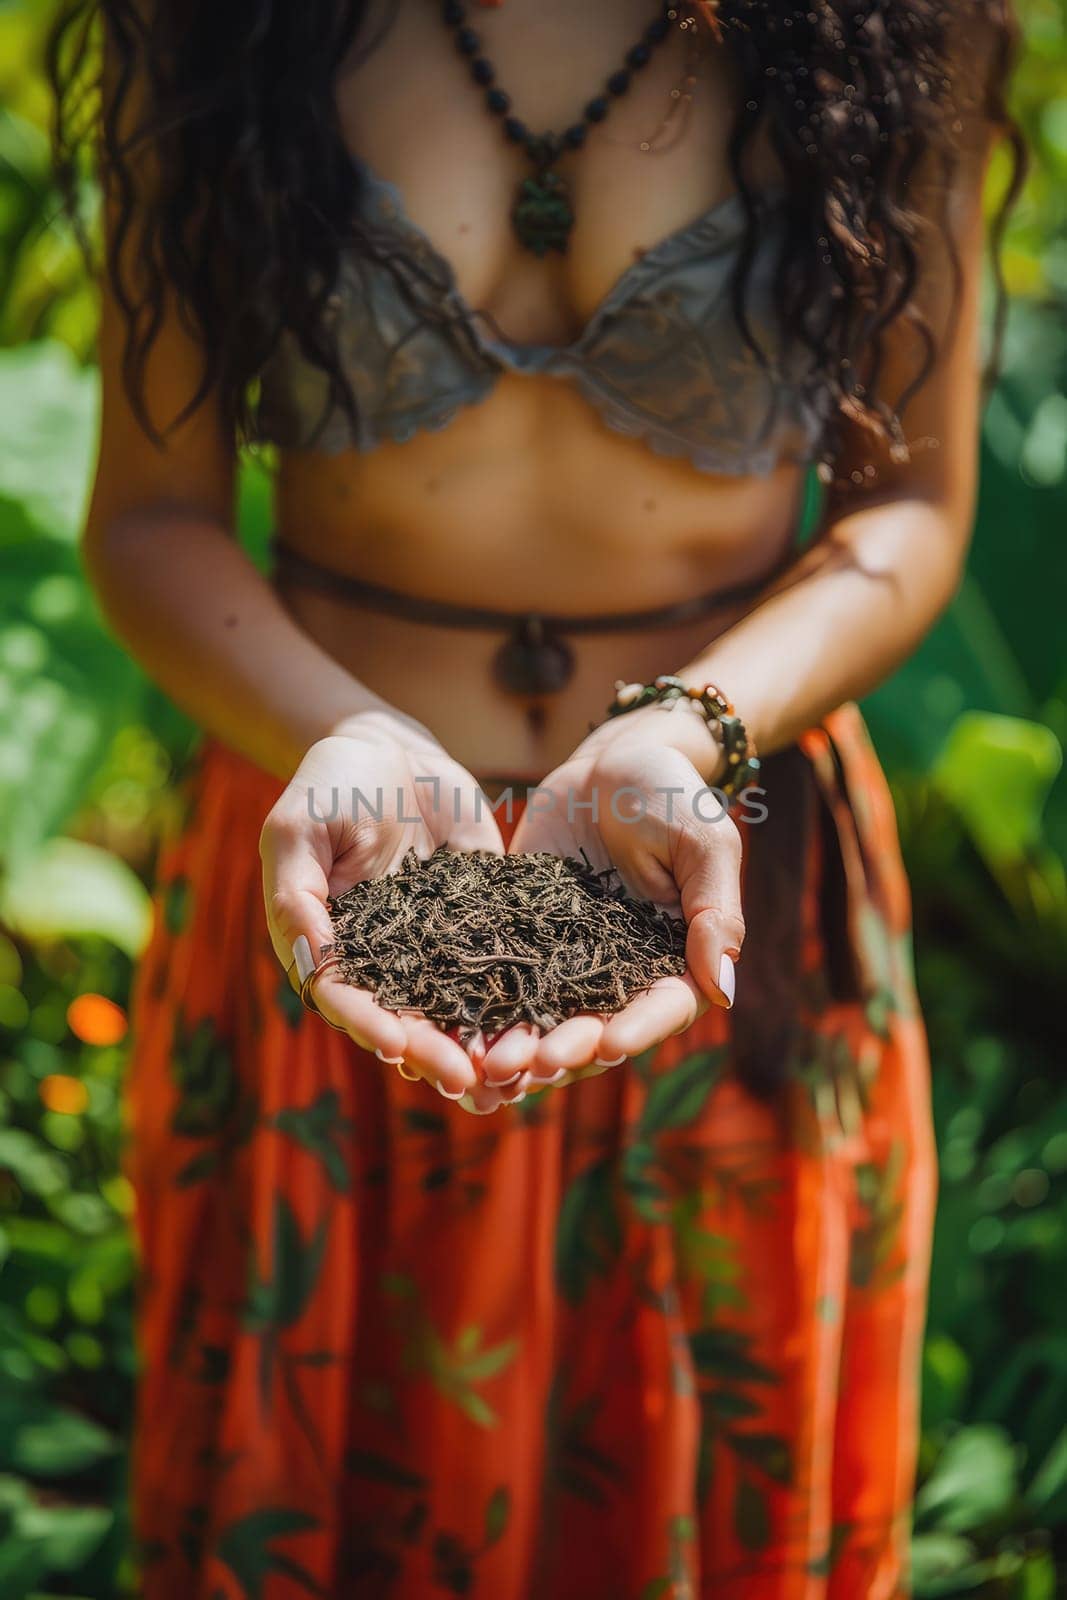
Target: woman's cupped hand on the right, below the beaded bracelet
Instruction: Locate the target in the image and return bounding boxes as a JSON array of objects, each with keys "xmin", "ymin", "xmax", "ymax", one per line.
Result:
[{"xmin": 482, "ymin": 704, "xmax": 744, "ymax": 1088}]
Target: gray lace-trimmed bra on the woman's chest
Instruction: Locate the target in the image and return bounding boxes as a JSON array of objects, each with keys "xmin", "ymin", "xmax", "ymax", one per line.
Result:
[{"xmin": 254, "ymin": 160, "xmax": 822, "ymax": 475}]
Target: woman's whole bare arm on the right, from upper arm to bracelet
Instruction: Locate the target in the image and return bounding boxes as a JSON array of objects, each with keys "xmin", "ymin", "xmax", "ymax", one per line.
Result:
[{"xmin": 680, "ymin": 103, "xmax": 992, "ymax": 755}]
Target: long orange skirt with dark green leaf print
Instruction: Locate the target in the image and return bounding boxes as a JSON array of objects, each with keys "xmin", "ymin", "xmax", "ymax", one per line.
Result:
[{"xmin": 128, "ymin": 706, "xmax": 936, "ymax": 1600}]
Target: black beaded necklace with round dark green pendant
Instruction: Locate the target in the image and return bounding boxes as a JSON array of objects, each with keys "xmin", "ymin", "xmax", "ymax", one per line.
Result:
[{"xmin": 442, "ymin": 0, "xmax": 675, "ymax": 256}]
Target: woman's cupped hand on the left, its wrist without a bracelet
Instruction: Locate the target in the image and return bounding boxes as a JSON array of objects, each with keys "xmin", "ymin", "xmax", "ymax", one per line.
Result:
[{"xmin": 259, "ymin": 709, "xmax": 504, "ymax": 1099}]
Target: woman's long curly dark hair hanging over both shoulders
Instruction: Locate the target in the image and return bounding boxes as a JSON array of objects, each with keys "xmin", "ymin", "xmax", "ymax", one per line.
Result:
[{"xmin": 50, "ymin": 0, "xmax": 1025, "ymax": 474}]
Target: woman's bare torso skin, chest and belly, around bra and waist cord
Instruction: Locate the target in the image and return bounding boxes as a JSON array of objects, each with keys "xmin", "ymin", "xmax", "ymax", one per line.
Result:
[{"xmin": 277, "ymin": 0, "xmax": 801, "ymax": 776}]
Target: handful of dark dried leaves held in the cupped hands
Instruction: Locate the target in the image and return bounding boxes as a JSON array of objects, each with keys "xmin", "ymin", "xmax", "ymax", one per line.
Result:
[{"xmin": 330, "ymin": 845, "xmax": 686, "ymax": 1042}]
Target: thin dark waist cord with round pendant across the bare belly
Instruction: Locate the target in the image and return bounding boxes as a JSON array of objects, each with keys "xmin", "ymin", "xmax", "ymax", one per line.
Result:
[{"xmin": 270, "ymin": 539, "xmax": 774, "ymax": 696}]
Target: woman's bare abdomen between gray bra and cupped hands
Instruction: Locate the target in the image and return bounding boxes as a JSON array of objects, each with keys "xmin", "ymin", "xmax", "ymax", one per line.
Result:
[{"xmin": 277, "ymin": 376, "xmax": 803, "ymax": 778}]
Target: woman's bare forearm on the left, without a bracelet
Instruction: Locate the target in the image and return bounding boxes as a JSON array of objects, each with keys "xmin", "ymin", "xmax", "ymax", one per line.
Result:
[{"xmin": 85, "ymin": 506, "xmax": 416, "ymax": 778}]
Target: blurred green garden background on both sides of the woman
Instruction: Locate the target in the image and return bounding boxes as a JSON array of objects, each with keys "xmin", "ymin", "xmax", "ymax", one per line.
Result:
[{"xmin": 0, "ymin": 0, "xmax": 1067, "ymax": 1600}]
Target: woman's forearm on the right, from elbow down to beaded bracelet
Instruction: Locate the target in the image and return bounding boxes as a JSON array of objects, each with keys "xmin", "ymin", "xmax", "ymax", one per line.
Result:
[{"xmin": 678, "ymin": 494, "xmax": 968, "ymax": 755}]
